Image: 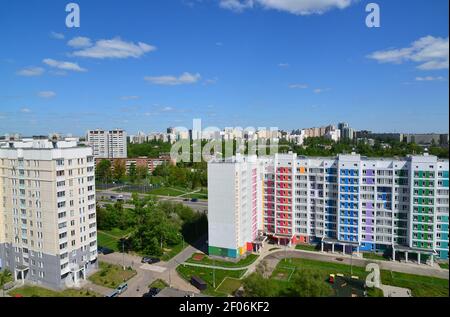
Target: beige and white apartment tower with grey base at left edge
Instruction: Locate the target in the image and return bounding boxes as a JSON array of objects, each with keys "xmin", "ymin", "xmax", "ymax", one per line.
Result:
[{"xmin": 0, "ymin": 139, "xmax": 97, "ymax": 288}]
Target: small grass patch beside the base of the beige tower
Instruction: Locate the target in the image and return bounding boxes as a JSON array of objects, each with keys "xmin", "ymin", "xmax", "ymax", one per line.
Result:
[{"xmin": 89, "ymin": 262, "xmax": 136, "ymax": 288}]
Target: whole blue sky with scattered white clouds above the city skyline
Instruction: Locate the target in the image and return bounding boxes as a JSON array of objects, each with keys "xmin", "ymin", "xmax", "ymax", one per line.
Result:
[{"xmin": 0, "ymin": 0, "xmax": 449, "ymax": 135}]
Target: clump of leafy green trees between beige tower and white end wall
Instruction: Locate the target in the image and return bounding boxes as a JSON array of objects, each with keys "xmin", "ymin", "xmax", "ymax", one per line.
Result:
[{"xmin": 97, "ymin": 194, "xmax": 208, "ymax": 256}]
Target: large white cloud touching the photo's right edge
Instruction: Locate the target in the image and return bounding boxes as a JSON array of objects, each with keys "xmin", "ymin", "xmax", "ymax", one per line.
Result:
[{"xmin": 368, "ymin": 35, "xmax": 449, "ymax": 70}]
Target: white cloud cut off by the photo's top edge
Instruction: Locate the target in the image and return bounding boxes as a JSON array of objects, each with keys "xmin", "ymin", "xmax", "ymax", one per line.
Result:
[{"xmin": 219, "ymin": 0, "xmax": 357, "ymax": 15}]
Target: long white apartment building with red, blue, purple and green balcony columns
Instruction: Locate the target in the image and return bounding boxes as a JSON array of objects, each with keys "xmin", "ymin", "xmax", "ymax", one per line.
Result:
[{"xmin": 208, "ymin": 154, "xmax": 449, "ymax": 262}]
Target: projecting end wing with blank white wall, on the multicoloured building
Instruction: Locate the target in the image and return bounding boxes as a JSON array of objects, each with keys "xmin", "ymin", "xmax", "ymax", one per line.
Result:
[{"xmin": 208, "ymin": 156, "xmax": 262, "ymax": 258}]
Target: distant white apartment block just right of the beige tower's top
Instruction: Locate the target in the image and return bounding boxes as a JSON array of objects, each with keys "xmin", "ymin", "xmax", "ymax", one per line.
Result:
[{"xmin": 86, "ymin": 129, "xmax": 127, "ymax": 158}]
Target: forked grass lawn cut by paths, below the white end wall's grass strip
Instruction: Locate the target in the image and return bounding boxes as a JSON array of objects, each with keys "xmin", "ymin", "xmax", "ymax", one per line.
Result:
[{"xmin": 177, "ymin": 265, "xmax": 247, "ymax": 296}]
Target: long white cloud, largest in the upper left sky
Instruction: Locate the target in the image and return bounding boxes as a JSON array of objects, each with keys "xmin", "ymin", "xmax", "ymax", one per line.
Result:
[{"xmin": 72, "ymin": 37, "xmax": 156, "ymax": 59}]
